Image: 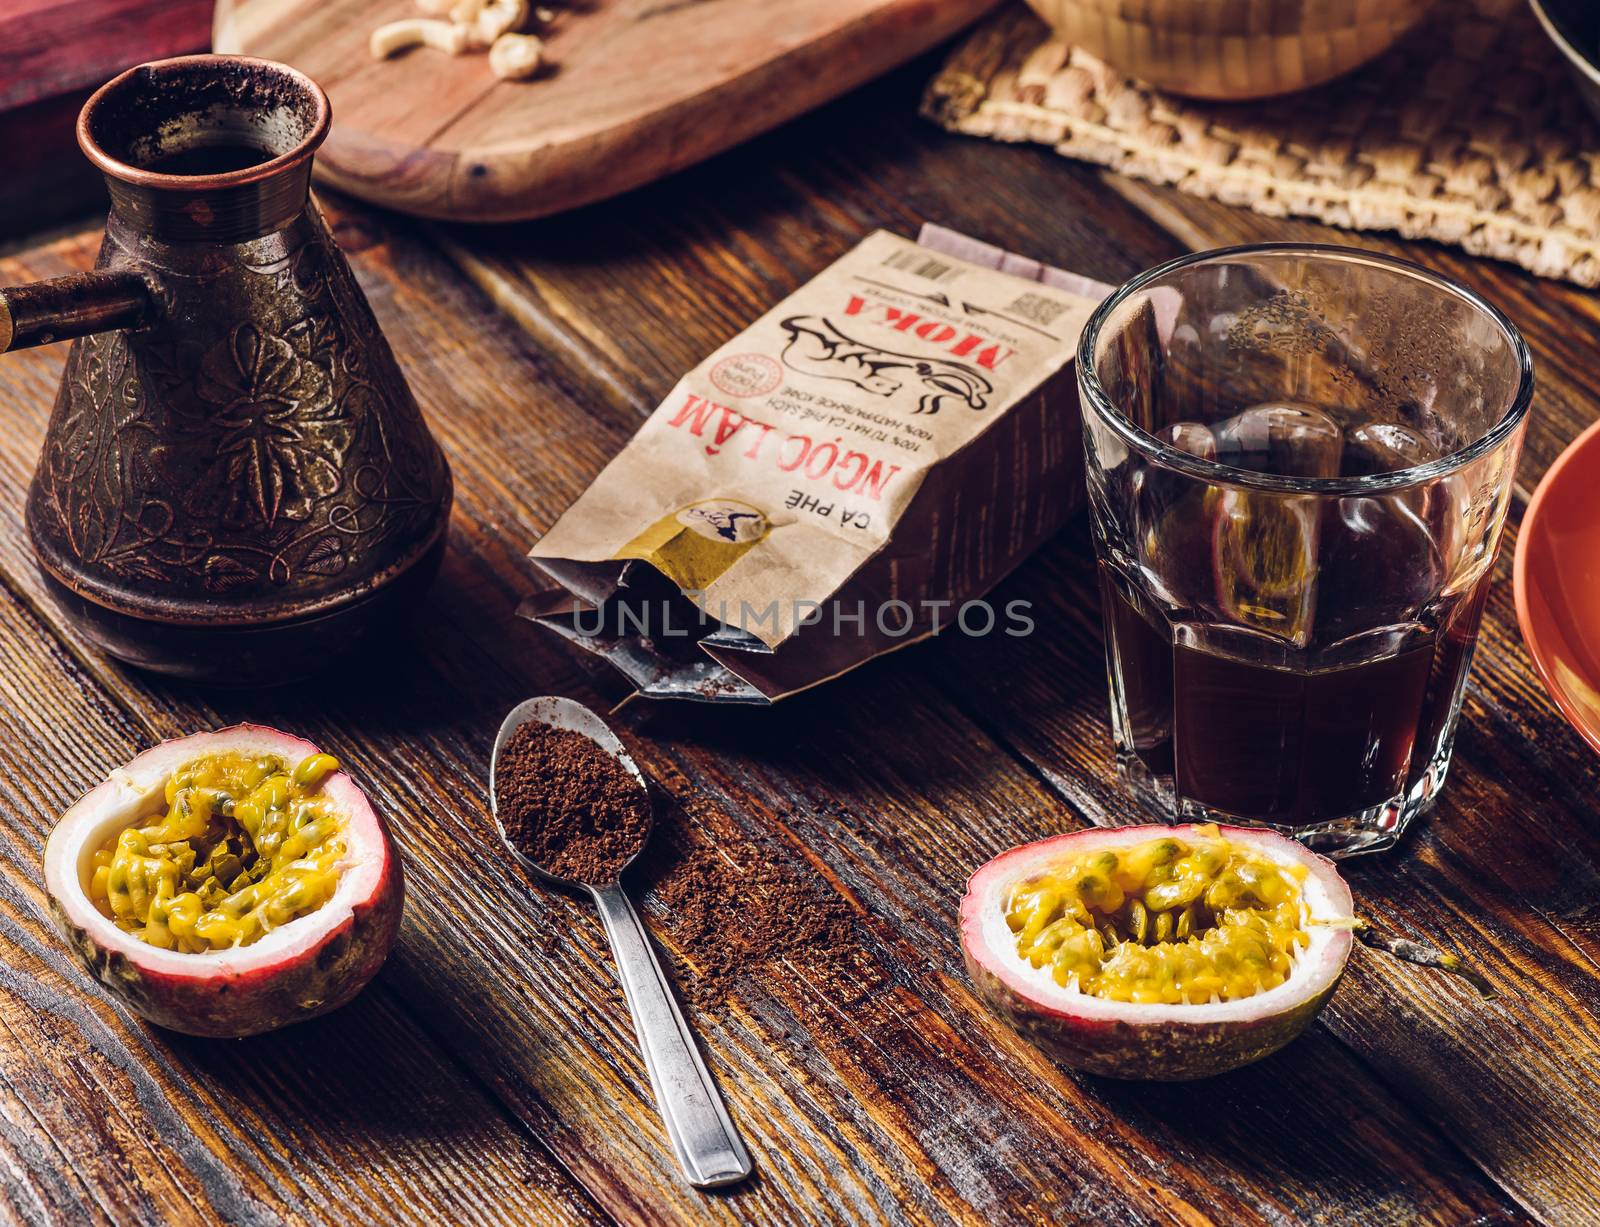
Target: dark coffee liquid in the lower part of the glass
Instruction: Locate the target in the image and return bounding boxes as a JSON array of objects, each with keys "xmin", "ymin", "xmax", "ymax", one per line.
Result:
[{"xmin": 1101, "ymin": 570, "xmax": 1488, "ymax": 825}]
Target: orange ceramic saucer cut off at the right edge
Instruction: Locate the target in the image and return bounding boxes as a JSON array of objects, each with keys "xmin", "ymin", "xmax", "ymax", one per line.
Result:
[{"xmin": 1515, "ymin": 422, "xmax": 1600, "ymax": 753}]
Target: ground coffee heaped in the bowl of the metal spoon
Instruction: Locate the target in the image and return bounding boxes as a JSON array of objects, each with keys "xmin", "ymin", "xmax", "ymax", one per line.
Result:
[{"xmin": 494, "ymin": 721, "xmax": 650, "ymax": 886}]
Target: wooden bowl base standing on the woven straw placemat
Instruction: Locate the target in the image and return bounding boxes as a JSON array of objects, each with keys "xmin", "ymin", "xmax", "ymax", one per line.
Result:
[{"xmin": 1027, "ymin": 0, "xmax": 1432, "ymax": 101}]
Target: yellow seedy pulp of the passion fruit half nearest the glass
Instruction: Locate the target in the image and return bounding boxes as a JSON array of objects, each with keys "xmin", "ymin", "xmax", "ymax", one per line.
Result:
[{"xmin": 1005, "ymin": 825, "xmax": 1312, "ymax": 1005}]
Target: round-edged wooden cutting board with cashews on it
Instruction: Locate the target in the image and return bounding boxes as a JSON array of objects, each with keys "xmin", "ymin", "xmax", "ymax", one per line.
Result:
[{"xmin": 214, "ymin": 0, "xmax": 994, "ymax": 221}]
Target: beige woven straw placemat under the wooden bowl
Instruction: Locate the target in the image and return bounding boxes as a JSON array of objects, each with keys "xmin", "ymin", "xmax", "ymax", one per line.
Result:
[{"xmin": 923, "ymin": 0, "xmax": 1600, "ymax": 286}]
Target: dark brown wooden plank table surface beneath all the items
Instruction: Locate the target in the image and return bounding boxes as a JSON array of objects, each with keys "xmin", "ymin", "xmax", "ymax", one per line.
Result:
[{"xmin": 0, "ymin": 50, "xmax": 1600, "ymax": 1227}]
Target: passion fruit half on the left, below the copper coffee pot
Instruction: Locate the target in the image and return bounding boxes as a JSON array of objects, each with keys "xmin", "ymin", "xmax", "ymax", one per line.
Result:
[{"xmin": 45, "ymin": 725, "xmax": 403, "ymax": 1037}]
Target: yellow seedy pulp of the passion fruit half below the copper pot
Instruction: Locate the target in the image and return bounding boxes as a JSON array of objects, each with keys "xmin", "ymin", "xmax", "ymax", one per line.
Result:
[{"xmin": 90, "ymin": 752, "xmax": 346, "ymax": 953}]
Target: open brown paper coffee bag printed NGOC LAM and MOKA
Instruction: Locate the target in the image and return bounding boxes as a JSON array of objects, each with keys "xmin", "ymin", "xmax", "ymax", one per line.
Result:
[{"xmin": 523, "ymin": 229, "xmax": 1109, "ymax": 702}]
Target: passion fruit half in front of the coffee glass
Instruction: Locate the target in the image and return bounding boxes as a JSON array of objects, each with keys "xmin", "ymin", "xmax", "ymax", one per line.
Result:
[{"xmin": 960, "ymin": 825, "xmax": 1357, "ymax": 1081}]
